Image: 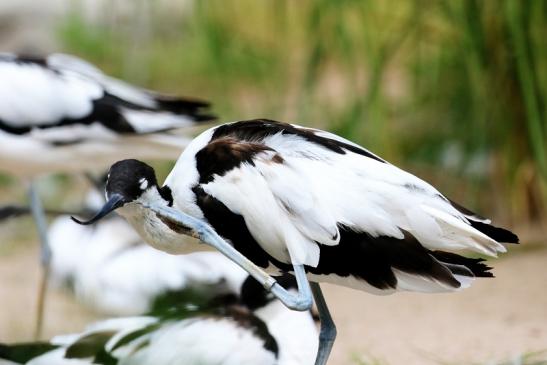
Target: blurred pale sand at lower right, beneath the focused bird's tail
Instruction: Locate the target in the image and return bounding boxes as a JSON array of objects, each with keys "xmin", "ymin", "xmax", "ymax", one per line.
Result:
[{"xmin": 326, "ymin": 242, "xmax": 547, "ymax": 365}]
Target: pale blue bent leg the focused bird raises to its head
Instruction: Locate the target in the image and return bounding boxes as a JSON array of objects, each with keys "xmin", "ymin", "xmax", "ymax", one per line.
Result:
[{"xmin": 148, "ymin": 205, "xmax": 313, "ymax": 311}]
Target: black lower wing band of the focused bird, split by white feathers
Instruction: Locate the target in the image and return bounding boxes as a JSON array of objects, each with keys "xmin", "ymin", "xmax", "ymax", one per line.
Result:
[{"xmin": 192, "ymin": 185, "xmax": 480, "ymax": 289}]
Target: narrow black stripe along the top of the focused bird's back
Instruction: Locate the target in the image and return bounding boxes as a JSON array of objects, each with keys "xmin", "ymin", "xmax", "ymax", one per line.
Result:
[{"xmin": 211, "ymin": 119, "xmax": 385, "ymax": 162}]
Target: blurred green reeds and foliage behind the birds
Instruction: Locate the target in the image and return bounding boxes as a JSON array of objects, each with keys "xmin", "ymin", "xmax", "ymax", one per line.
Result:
[{"xmin": 59, "ymin": 0, "xmax": 547, "ymax": 222}]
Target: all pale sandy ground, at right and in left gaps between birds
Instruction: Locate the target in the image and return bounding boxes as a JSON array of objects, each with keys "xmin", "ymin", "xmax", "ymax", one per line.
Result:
[{"xmin": 0, "ymin": 226, "xmax": 547, "ymax": 365}]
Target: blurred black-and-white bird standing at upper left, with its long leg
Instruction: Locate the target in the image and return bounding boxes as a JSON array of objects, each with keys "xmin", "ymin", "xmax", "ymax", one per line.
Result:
[{"xmin": 0, "ymin": 53, "xmax": 217, "ymax": 333}]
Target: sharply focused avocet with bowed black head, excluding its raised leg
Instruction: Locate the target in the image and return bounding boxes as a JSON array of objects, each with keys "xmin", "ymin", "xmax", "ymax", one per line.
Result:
[{"xmin": 75, "ymin": 120, "xmax": 518, "ymax": 364}]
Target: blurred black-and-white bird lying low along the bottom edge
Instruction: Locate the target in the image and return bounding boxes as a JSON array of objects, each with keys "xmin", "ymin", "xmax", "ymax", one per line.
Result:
[{"xmin": 0, "ymin": 279, "xmax": 317, "ymax": 365}]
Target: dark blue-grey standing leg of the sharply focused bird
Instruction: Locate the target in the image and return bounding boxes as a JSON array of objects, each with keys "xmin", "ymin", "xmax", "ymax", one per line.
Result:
[{"xmin": 310, "ymin": 282, "xmax": 336, "ymax": 365}]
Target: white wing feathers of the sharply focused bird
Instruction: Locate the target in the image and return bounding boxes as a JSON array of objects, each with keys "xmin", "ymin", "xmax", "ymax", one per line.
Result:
[{"xmin": 205, "ymin": 132, "xmax": 505, "ymax": 266}]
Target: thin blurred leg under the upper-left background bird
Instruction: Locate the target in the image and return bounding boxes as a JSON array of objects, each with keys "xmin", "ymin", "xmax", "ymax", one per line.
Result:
[{"xmin": 29, "ymin": 181, "xmax": 51, "ymax": 339}]
